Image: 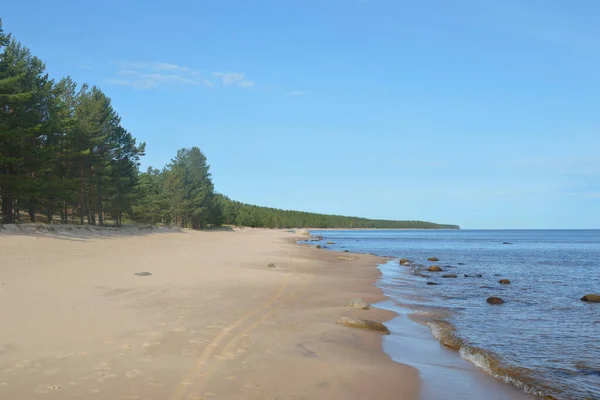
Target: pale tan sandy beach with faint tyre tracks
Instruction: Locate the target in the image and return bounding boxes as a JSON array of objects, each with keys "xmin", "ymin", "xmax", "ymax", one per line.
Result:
[{"xmin": 0, "ymin": 229, "xmax": 419, "ymax": 400}]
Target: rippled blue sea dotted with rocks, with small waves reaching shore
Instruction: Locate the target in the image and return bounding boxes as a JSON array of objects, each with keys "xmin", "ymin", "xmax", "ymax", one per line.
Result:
[{"xmin": 309, "ymin": 230, "xmax": 600, "ymax": 400}]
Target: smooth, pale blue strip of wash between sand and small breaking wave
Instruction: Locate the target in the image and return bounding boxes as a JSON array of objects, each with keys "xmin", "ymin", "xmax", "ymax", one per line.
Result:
[{"xmin": 305, "ymin": 229, "xmax": 534, "ymax": 400}]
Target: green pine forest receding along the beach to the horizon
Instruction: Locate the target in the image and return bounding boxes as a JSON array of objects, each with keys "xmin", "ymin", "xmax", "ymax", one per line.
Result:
[{"xmin": 0, "ymin": 20, "xmax": 457, "ymax": 229}]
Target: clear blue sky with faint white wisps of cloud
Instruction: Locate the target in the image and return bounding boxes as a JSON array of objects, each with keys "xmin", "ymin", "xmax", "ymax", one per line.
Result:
[{"xmin": 0, "ymin": 0, "xmax": 600, "ymax": 228}]
